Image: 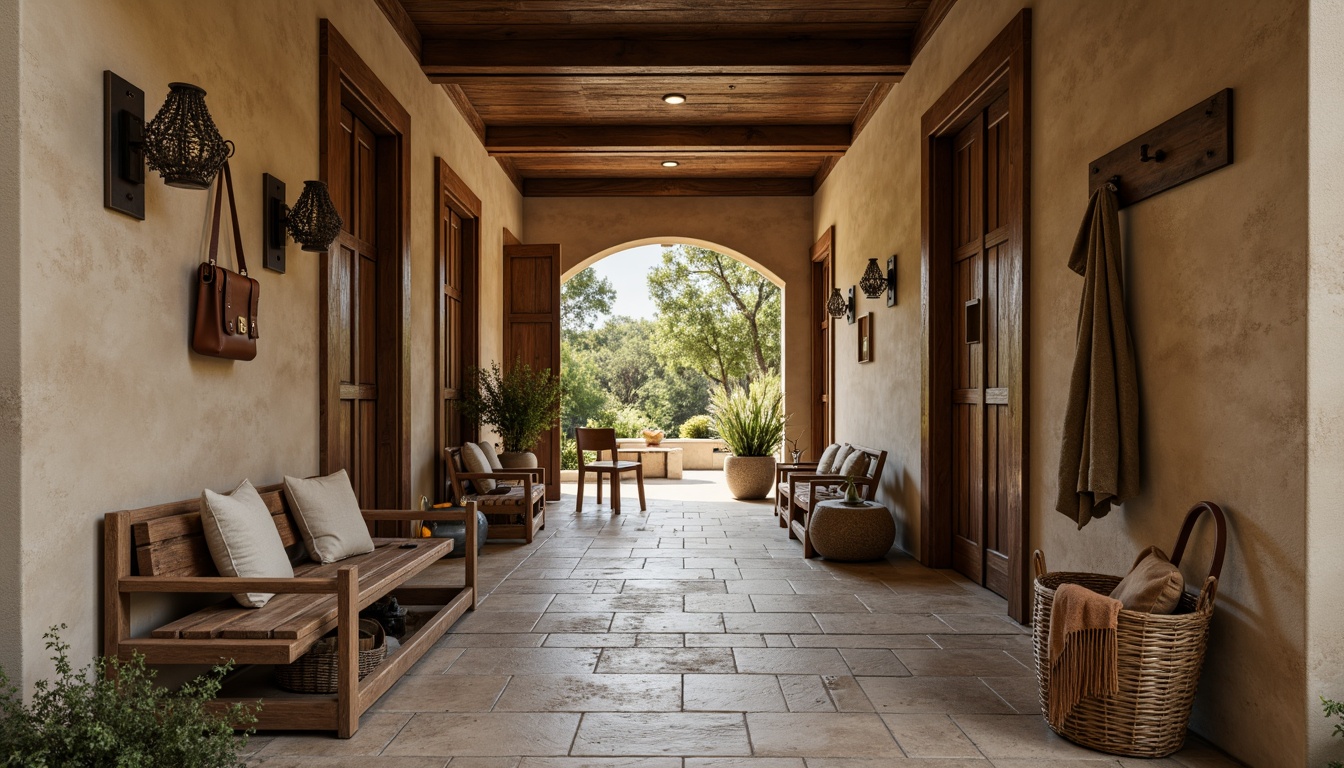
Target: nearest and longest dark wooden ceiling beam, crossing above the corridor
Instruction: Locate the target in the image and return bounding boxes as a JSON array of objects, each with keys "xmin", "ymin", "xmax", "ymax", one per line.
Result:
[{"xmin": 421, "ymin": 36, "xmax": 911, "ymax": 82}]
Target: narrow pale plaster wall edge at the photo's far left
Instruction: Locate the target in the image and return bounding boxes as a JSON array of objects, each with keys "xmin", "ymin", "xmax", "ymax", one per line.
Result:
[{"xmin": 0, "ymin": 0, "xmax": 23, "ymax": 685}]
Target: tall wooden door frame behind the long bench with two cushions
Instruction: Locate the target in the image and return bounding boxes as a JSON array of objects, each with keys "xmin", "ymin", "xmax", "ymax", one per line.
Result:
[{"xmin": 317, "ymin": 19, "xmax": 411, "ymax": 510}]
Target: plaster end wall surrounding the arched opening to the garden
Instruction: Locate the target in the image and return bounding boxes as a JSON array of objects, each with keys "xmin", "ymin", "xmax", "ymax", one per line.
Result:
[{"xmin": 523, "ymin": 198, "xmax": 816, "ymax": 447}]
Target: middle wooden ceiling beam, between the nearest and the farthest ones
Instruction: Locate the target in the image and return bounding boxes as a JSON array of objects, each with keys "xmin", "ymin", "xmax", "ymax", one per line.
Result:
[{"xmin": 485, "ymin": 125, "xmax": 851, "ymax": 156}]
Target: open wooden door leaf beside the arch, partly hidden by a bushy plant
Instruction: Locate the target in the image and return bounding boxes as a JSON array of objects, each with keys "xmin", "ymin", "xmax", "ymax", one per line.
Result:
[{"xmin": 504, "ymin": 245, "xmax": 560, "ymax": 499}]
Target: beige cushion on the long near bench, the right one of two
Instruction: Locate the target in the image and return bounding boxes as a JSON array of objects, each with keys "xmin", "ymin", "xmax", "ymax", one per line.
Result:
[{"xmin": 285, "ymin": 469, "xmax": 374, "ymax": 562}]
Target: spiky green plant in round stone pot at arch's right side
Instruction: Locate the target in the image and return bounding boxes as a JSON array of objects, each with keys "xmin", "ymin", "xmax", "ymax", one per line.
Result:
[{"xmin": 710, "ymin": 377, "xmax": 785, "ymax": 499}]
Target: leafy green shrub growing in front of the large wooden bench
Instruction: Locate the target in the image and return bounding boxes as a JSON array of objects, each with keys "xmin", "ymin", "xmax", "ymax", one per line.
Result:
[{"xmin": 0, "ymin": 624, "xmax": 259, "ymax": 768}]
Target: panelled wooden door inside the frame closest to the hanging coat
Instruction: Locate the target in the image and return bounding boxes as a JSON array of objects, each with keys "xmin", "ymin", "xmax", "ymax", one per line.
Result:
[{"xmin": 950, "ymin": 94, "xmax": 1016, "ymax": 596}]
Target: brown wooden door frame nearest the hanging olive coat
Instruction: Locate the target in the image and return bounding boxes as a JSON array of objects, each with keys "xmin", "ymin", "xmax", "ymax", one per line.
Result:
[{"xmin": 919, "ymin": 8, "xmax": 1031, "ymax": 623}]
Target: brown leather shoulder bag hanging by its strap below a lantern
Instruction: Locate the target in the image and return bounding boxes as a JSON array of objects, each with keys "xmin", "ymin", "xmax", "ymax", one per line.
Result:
[{"xmin": 191, "ymin": 163, "xmax": 261, "ymax": 360}]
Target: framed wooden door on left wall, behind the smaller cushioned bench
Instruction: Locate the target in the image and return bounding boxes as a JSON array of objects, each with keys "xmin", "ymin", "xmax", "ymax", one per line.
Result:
[{"xmin": 434, "ymin": 157, "xmax": 481, "ymax": 502}]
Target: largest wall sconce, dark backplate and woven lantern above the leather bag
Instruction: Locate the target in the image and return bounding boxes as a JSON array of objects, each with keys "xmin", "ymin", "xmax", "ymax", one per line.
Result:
[{"xmin": 102, "ymin": 71, "xmax": 234, "ymax": 221}]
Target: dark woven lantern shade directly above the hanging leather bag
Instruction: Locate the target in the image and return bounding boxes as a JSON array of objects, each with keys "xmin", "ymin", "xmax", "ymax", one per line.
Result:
[{"xmin": 145, "ymin": 82, "xmax": 234, "ymax": 190}]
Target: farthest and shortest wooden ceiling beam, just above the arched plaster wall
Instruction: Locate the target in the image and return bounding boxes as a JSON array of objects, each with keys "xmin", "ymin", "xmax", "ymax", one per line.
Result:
[{"xmin": 523, "ymin": 176, "xmax": 812, "ymax": 198}]
